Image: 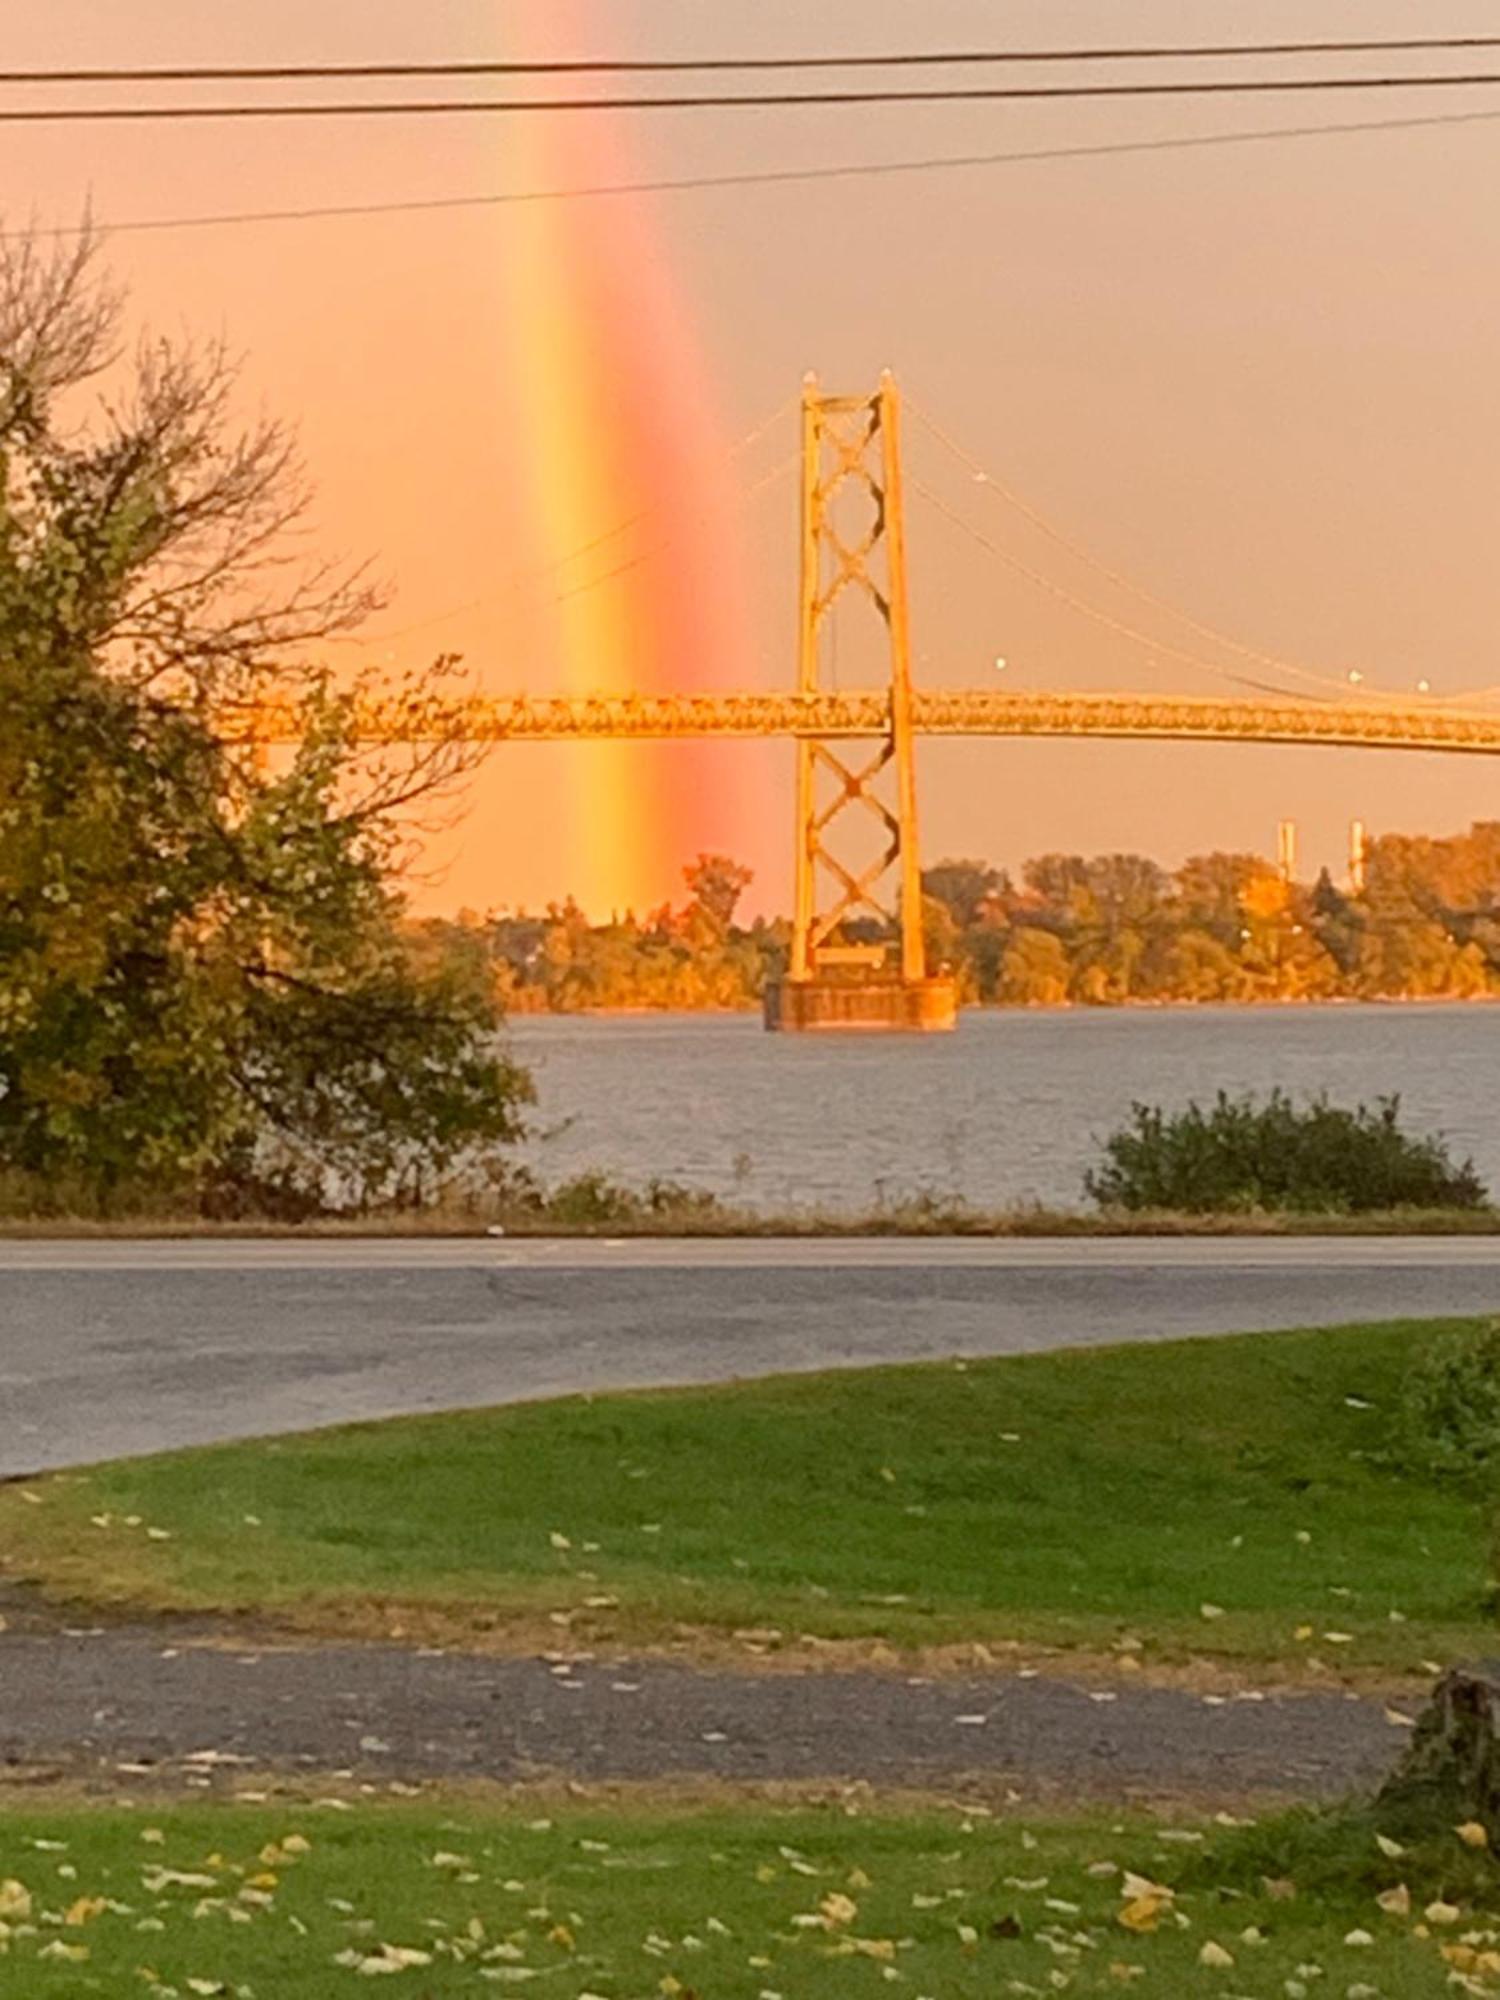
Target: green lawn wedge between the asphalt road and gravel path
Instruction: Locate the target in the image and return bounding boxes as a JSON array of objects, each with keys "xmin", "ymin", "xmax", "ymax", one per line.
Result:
[{"xmin": 0, "ymin": 1322, "xmax": 1494, "ymax": 1670}]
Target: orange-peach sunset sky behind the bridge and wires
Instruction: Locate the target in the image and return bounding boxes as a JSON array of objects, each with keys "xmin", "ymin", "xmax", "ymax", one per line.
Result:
[{"xmin": 11, "ymin": 0, "xmax": 1500, "ymax": 908}]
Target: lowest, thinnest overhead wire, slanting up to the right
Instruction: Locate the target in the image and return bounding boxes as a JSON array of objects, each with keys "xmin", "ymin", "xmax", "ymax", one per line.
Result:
[{"xmin": 17, "ymin": 112, "xmax": 1500, "ymax": 242}]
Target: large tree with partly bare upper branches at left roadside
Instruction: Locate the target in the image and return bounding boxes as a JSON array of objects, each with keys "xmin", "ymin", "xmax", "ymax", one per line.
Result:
[{"xmin": 0, "ymin": 236, "xmax": 526, "ymax": 1206}]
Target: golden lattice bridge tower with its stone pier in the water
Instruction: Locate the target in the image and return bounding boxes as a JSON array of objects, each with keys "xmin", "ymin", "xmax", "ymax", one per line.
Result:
[{"xmin": 766, "ymin": 372, "xmax": 956, "ymax": 1032}]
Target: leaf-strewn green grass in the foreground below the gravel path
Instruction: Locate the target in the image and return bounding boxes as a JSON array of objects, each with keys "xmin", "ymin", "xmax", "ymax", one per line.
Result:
[{"xmin": 0, "ymin": 1806, "xmax": 1500, "ymax": 2000}]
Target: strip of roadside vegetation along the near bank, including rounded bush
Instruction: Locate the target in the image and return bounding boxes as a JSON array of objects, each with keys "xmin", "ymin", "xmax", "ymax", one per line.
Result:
[{"xmin": 0, "ymin": 1092, "xmax": 1500, "ymax": 1236}]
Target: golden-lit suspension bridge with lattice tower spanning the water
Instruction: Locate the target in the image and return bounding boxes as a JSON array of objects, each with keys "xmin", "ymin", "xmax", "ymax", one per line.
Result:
[{"xmin": 250, "ymin": 374, "xmax": 1500, "ymax": 1030}]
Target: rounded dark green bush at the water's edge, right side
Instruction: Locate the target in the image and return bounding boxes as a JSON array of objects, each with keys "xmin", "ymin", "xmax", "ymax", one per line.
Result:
[{"xmin": 1084, "ymin": 1090, "xmax": 1490, "ymax": 1214}]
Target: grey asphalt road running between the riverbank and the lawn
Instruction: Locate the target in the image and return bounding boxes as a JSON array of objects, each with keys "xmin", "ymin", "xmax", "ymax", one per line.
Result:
[{"xmin": 0, "ymin": 1238, "xmax": 1500, "ymax": 1476}]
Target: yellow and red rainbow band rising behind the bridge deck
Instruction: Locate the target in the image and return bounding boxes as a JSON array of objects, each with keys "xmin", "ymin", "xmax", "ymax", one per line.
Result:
[{"xmin": 494, "ymin": 0, "xmax": 756, "ymax": 914}]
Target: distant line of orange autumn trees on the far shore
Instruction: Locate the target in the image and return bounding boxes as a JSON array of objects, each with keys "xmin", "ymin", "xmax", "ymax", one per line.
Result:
[{"xmin": 416, "ymin": 822, "xmax": 1500, "ymax": 1014}]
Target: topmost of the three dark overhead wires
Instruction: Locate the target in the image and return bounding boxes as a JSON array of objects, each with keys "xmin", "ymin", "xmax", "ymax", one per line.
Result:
[{"xmin": 0, "ymin": 34, "xmax": 1500, "ymax": 84}]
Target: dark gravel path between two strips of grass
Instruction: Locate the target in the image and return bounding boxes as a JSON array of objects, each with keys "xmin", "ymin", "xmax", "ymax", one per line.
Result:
[{"xmin": 0, "ymin": 1620, "xmax": 1406, "ymax": 1804}]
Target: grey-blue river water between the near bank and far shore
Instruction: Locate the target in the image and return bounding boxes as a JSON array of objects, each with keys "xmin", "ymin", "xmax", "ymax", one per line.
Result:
[{"xmin": 514, "ymin": 1006, "xmax": 1500, "ymax": 1208}]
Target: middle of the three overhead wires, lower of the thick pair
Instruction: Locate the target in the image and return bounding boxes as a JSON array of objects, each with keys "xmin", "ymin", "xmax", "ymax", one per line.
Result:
[{"xmin": 0, "ymin": 70, "xmax": 1500, "ymax": 124}]
